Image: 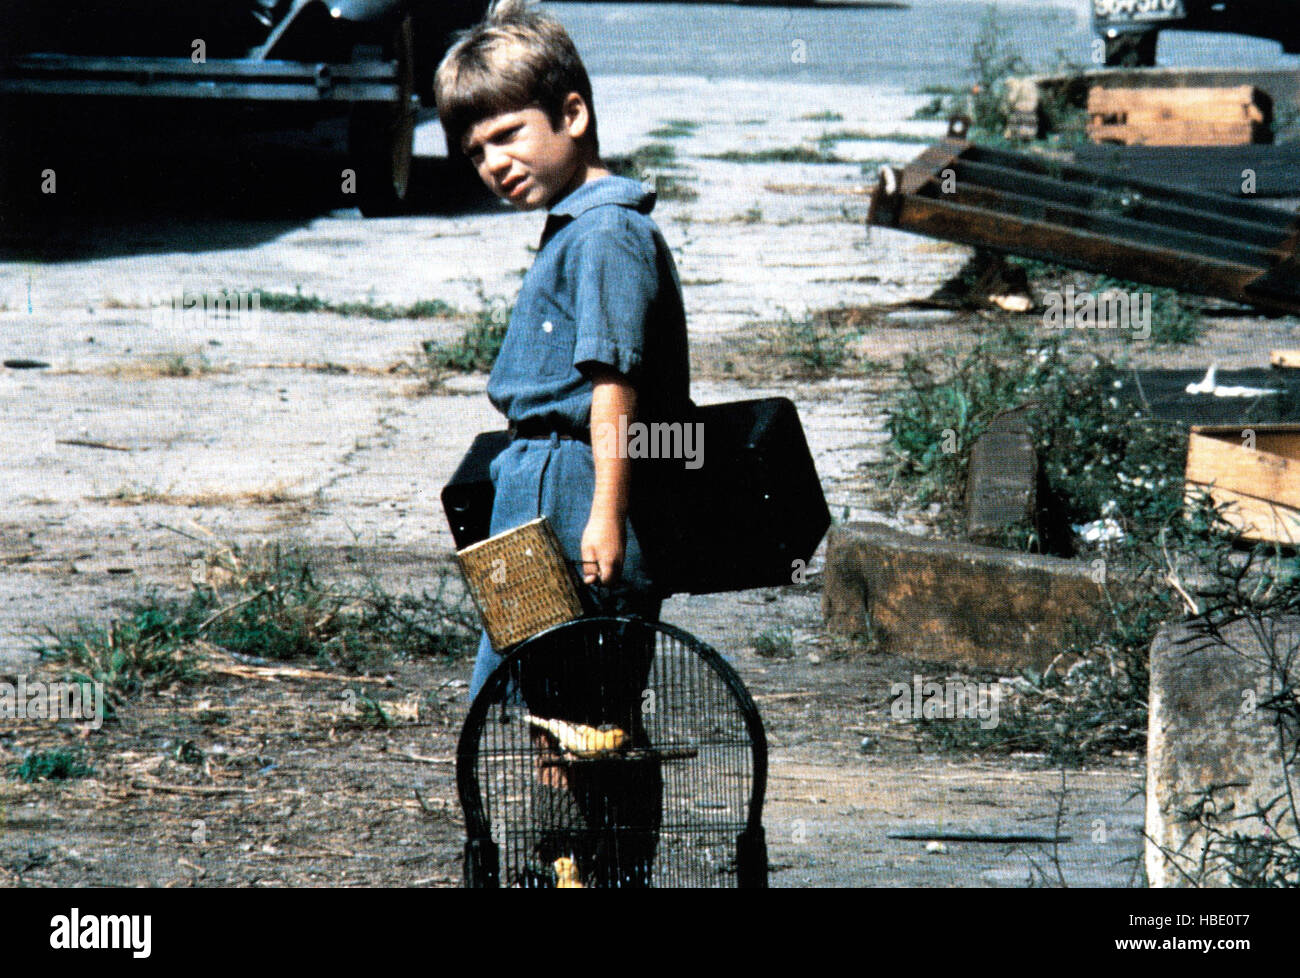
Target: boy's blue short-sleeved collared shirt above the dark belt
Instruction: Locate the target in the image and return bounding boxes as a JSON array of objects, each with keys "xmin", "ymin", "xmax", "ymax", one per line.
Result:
[{"xmin": 488, "ymin": 177, "xmax": 690, "ymax": 429}]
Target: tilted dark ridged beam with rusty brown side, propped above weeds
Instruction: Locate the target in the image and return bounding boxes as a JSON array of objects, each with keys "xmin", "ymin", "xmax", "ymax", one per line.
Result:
[{"xmin": 867, "ymin": 121, "xmax": 1300, "ymax": 315}]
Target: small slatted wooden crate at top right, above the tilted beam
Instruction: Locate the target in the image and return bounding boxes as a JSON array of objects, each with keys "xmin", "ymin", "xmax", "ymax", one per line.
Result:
[{"xmin": 1088, "ymin": 85, "xmax": 1273, "ymax": 146}]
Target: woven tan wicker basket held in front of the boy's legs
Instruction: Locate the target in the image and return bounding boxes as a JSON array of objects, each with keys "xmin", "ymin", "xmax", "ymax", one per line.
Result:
[{"xmin": 456, "ymin": 516, "xmax": 582, "ymax": 652}]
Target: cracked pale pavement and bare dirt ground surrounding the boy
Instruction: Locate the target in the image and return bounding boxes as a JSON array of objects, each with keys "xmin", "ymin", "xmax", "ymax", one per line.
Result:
[{"xmin": 0, "ymin": 78, "xmax": 1295, "ymax": 886}]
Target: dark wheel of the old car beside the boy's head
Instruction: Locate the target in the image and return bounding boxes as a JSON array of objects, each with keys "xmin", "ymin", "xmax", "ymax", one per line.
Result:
[{"xmin": 347, "ymin": 14, "xmax": 416, "ymax": 217}]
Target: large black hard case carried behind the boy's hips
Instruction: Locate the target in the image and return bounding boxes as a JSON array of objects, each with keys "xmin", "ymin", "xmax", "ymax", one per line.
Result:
[{"xmin": 442, "ymin": 398, "xmax": 831, "ymax": 596}]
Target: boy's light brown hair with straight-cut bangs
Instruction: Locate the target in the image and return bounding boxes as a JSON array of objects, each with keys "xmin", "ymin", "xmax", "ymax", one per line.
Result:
[{"xmin": 434, "ymin": 0, "xmax": 599, "ymax": 153}]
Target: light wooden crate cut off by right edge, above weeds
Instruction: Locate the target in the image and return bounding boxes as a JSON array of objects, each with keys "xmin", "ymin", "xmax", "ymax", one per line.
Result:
[{"xmin": 1187, "ymin": 424, "xmax": 1300, "ymax": 544}]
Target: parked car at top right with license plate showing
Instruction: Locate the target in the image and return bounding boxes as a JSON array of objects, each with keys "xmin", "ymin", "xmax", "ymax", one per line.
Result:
[{"xmin": 1092, "ymin": 0, "xmax": 1300, "ymax": 66}]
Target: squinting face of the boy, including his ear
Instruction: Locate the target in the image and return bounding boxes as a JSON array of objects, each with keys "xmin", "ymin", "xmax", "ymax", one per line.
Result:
[{"xmin": 462, "ymin": 92, "xmax": 588, "ymax": 211}]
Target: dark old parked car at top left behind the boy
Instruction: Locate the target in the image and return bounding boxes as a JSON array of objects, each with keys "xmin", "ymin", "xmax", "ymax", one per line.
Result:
[{"xmin": 0, "ymin": 0, "xmax": 488, "ymax": 215}]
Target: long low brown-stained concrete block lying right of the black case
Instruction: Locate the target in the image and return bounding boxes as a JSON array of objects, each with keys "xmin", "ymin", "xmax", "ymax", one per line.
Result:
[{"xmin": 822, "ymin": 523, "xmax": 1106, "ymax": 671}]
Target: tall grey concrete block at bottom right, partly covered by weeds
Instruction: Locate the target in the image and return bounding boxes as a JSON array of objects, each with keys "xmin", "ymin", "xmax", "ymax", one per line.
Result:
[{"xmin": 1147, "ymin": 619, "xmax": 1300, "ymax": 887}]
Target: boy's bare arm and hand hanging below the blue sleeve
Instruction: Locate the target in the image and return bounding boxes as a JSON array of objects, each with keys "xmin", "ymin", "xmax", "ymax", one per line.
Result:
[{"xmin": 582, "ymin": 363, "xmax": 637, "ymax": 585}]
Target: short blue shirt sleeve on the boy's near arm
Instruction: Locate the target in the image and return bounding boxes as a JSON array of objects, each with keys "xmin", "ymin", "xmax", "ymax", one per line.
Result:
[{"xmin": 571, "ymin": 225, "xmax": 659, "ymax": 378}]
